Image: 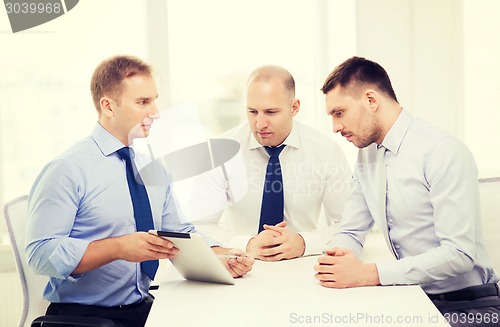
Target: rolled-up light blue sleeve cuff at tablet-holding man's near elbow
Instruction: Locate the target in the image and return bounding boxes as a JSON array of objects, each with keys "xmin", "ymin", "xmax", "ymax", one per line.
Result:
[{"xmin": 49, "ymin": 237, "xmax": 90, "ymax": 281}]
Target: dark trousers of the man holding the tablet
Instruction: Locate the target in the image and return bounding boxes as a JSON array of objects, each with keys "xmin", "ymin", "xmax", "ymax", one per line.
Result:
[{"xmin": 44, "ymin": 295, "xmax": 154, "ymax": 327}]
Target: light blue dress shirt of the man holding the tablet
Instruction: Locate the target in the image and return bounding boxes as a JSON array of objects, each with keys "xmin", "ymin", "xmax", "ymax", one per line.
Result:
[{"xmin": 26, "ymin": 124, "xmax": 215, "ymax": 306}]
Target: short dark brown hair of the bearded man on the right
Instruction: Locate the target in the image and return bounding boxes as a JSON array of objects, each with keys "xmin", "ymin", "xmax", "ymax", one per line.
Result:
[{"xmin": 321, "ymin": 57, "xmax": 398, "ymax": 102}]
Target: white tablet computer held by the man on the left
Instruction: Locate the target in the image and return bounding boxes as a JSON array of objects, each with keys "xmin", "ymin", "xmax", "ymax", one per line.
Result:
[{"xmin": 149, "ymin": 230, "xmax": 234, "ymax": 285}]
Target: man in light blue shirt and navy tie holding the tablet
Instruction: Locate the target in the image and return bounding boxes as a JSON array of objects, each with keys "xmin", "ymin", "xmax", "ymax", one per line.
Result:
[{"xmin": 26, "ymin": 56, "xmax": 254, "ymax": 326}]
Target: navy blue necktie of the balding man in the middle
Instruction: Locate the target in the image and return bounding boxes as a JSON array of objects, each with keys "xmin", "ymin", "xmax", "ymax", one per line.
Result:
[{"xmin": 259, "ymin": 144, "xmax": 285, "ymax": 233}]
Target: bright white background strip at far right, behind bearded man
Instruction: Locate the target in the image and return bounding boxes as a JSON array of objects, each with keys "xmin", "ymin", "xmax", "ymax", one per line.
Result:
[{"xmin": 463, "ymin": 0, "xmax": 500, "ymax": 178}]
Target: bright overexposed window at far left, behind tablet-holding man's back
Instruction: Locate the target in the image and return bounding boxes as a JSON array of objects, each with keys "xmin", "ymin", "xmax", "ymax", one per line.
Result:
[{"xmin": 0, "ymin": 0, "xmax": 148, "ymax": 240}]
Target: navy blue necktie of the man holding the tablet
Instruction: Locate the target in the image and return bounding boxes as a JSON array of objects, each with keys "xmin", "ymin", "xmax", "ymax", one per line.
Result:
[{"xmin": 116, "ymin": 147, "xmax": 158, "ymax": 280}]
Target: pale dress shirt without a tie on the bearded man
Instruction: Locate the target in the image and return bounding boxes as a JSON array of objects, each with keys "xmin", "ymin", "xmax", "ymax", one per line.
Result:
[{"xmin": 330, "ymin": 110, "xmax": 498, "ymax": 293}]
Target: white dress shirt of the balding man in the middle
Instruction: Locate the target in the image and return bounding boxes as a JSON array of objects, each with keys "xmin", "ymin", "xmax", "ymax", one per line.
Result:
[{"xmin": 178, "ymin": 121, "xmax": 352, "ymax": 255}]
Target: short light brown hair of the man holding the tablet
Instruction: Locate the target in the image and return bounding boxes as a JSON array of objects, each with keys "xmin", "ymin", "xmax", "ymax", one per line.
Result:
[{"xmin": 90, "ymin": 55, "xmax": 152, "ymax": 113}]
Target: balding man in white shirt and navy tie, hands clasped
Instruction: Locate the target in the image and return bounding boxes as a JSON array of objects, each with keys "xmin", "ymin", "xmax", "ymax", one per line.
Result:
[{"xmin": 188, "ymin": 66, "xmax": 351, "ymax": 261}]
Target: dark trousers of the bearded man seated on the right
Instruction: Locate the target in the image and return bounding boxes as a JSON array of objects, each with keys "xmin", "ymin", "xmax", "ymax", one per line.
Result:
[{"xmin": 428, "ymin": 284, "xmax": 500, "ymax": 327}]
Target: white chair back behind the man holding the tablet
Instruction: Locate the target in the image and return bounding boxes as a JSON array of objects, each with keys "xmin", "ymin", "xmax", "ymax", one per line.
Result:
[{"xmin": 4, "ymin": 195, "xmax": 49, "ymax": 327}]
